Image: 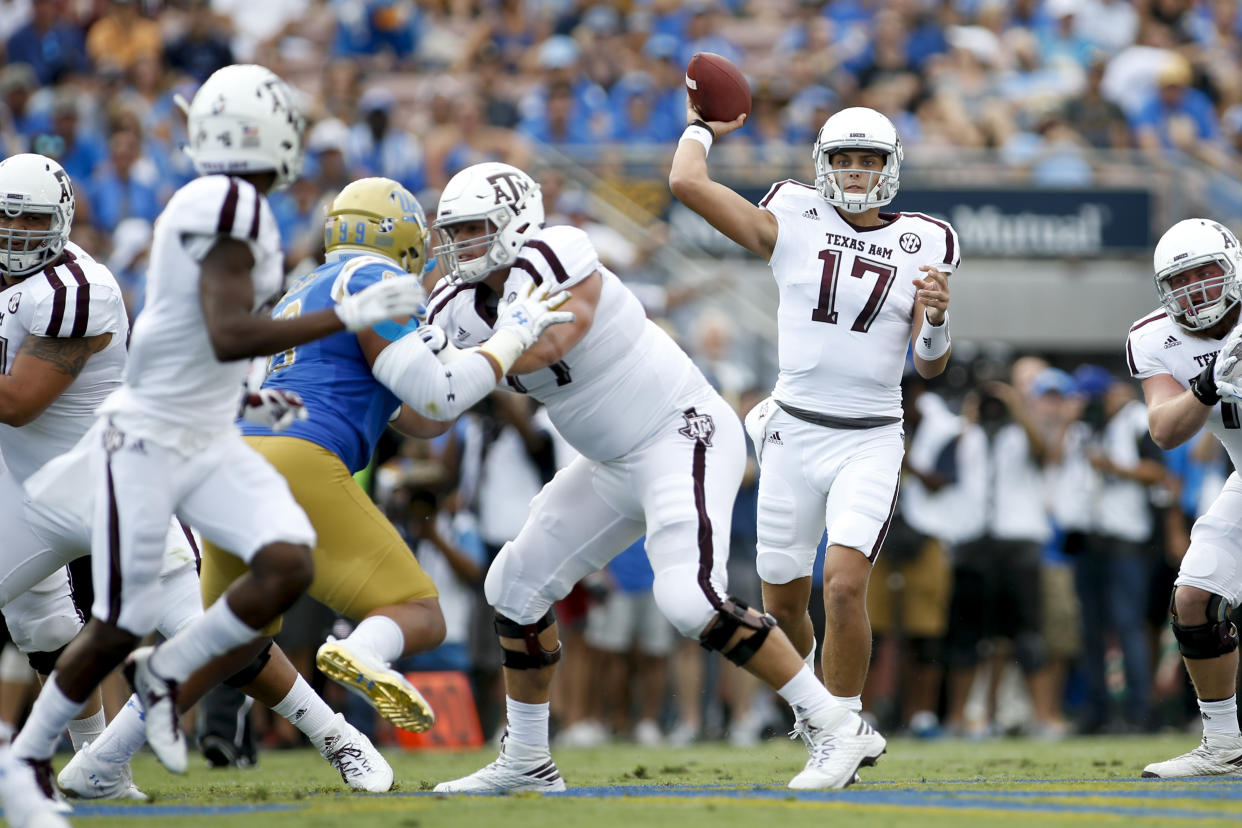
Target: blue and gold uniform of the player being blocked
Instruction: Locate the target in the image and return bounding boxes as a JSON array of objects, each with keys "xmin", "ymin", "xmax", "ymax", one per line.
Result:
[{"xmin": 202, "ymin": 182, "xmax": 437, "ymax": 633}]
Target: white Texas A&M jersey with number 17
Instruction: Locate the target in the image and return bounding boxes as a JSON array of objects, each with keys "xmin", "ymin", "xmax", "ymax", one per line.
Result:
[{"xmin": 759, "ymin": 181, "xmax": 961, "ymax": 418}]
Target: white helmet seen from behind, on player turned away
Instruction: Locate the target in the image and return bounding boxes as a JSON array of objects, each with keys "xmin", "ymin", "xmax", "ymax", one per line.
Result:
[{"xmin": 179, "ymin": 63, "xmax": 306, "ymax": 190}]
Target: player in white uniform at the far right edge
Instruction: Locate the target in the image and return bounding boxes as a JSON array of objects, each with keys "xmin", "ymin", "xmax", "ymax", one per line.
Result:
[{"xmin": 1125, "ymin": 218, "xmax": 1242, "ymax": 777}]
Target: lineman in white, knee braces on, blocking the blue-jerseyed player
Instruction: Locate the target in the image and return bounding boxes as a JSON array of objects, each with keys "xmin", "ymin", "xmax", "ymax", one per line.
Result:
[{"xmin": 427, "ymin": 163, "xmax": 864, "ymax": 793}]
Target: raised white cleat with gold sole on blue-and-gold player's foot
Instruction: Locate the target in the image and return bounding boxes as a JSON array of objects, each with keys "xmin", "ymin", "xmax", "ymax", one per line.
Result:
[{"xmin": 314, "ymin": 636, "xmax": 436, "ymax": 734}]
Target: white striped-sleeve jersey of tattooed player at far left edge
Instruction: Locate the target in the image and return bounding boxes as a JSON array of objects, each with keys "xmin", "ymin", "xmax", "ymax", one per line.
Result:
[{"xmin": 0, "ymin": 242, "xmax": 129, "ymax": 483}]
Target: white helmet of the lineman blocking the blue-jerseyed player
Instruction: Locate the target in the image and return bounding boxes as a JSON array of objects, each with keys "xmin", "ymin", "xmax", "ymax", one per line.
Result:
[{"xmin": 432, "ymin": 161, "xmax": 544, "ymax": 284}]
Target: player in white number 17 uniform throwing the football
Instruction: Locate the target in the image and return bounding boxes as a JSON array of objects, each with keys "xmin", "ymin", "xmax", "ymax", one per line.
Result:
[{"xmin": 668, "ymin": 106, "xmax": 960, "ymax": 786}]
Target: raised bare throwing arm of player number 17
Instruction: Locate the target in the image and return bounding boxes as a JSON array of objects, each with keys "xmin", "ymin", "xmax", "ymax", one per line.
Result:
[{"xmin": 668, "ymin": 99, "xmax": 777, "ymax": 262}]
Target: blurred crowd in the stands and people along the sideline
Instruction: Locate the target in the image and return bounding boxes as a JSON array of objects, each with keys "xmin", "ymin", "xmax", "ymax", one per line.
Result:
[{"xmin": 0, "ymin": 0, "xmax": 1242, "ymax": 745}]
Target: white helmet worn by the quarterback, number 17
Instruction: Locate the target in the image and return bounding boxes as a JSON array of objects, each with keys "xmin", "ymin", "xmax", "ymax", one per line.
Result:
[{"xmin": 811, "ymin": 107, "xmax": 903, "ymax": 212}]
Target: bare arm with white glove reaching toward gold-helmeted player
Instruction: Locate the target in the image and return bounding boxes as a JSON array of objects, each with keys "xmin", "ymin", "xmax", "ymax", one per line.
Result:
[{"xmin": 199, "ymin": 238, "xmax": 424, "ymax": 362}]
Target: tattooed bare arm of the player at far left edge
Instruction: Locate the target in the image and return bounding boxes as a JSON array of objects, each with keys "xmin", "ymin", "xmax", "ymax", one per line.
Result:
[{"xmin": 0, "ymin": 333, "xmax": 112, "ymax": 427}]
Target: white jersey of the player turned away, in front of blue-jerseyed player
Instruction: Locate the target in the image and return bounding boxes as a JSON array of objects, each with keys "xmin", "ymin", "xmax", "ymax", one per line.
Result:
[{"xmin": 102, "ymin": 175, "xmax": 283, "ymax": 451}]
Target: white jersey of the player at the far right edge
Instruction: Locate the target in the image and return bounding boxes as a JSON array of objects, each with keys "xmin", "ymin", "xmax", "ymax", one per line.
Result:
[{"xmin": 1125, "ymin": 309, "xmax": 1242, "ymax": 468}]
